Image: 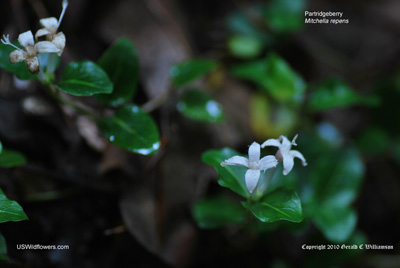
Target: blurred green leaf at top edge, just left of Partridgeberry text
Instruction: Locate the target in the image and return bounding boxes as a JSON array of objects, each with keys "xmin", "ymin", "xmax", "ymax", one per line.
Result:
[{"xmin": 263, "ymin": 0, "xmax": 306, "ymax": 33}]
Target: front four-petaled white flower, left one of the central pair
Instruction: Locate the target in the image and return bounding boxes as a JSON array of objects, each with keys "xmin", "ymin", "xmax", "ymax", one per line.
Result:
[{"xmin": 221, "ymin": 142, "xmax": 278, "ymax": 193}]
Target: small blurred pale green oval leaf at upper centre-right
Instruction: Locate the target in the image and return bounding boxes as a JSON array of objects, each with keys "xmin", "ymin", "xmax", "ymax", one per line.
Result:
[{"xmin": 228, "ymin": 35, "xmax": 263, "ymax": 59}]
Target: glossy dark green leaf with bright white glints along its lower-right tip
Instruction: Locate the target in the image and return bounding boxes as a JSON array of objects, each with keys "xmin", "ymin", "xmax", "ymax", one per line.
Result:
[{"xmin": 99, "ymin": 105, "xmax": 160, "ymax": 155}]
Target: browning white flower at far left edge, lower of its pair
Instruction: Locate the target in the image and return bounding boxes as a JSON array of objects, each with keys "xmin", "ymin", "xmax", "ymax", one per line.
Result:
[{"xmin": 1, "ymin": 31, "xmax": 60, "ymax": 74}]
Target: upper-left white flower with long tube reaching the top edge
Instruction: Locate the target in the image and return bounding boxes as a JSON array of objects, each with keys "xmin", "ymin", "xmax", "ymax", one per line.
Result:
[{"xmin": 35, "ymin": 0, "xmax": 68, "ymax": 56}]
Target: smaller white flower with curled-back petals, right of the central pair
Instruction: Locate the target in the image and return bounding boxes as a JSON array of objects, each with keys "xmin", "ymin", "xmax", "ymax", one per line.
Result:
[{"xmin": 261, "ymin": 135, "xmax": 307, "ymax": 175}]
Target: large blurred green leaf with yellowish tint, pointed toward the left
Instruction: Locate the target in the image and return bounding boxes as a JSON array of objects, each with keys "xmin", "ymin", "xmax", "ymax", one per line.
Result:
[{"xmin": 231, "ymin": 53, "xmax": 306, "ymax": 103}]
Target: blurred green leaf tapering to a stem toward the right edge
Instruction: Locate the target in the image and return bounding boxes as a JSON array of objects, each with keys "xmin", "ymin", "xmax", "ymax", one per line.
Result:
[{"xmin": 309, "ymin": 79, "xmax": 379, "ymax": 111}]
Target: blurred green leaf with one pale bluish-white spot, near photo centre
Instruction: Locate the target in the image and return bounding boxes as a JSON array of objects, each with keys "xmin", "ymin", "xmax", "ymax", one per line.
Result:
[{"xmin": 177, "ymin": 89, "xmax": 224, "ymax": 123}]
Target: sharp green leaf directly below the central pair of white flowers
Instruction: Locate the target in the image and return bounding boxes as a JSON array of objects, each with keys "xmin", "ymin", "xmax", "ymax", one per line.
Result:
[{"xmin": 242, "ymin": 188, "xmax": 303, "ymax": 222}]
